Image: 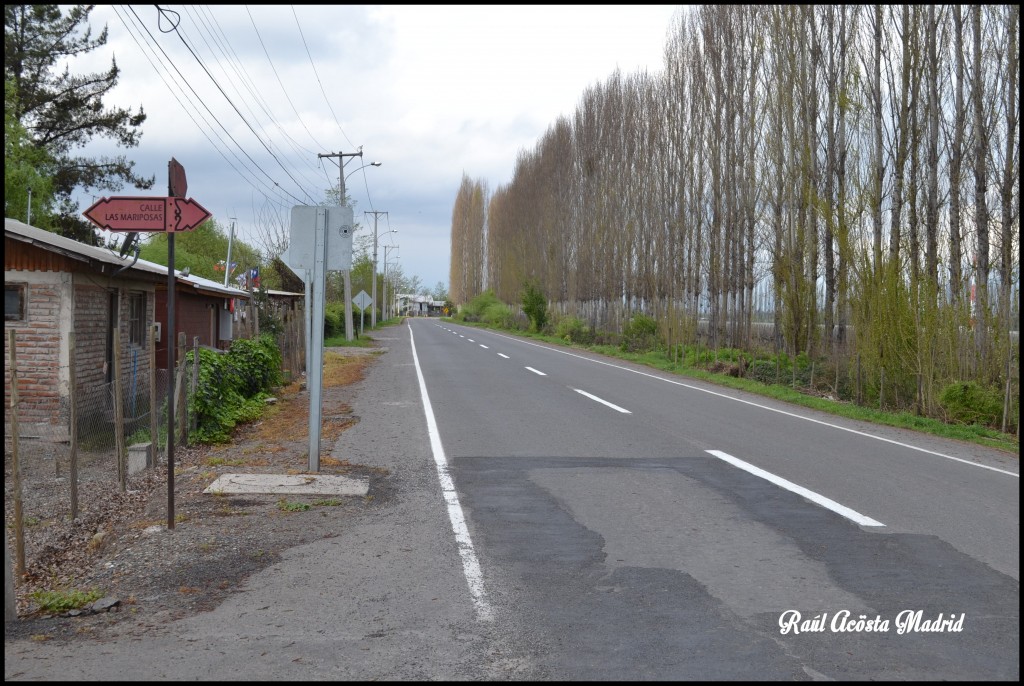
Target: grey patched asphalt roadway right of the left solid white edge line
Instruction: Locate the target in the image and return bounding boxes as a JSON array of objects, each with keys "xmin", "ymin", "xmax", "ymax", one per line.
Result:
[{"xmin": 409, "ymin": 319, "xmax": 1020, "ymax": 680}]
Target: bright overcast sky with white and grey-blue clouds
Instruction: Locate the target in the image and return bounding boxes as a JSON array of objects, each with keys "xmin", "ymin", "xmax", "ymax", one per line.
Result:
[{"xmin": 71, "ymin": 5, "xmax": 681, "ymax": 288}]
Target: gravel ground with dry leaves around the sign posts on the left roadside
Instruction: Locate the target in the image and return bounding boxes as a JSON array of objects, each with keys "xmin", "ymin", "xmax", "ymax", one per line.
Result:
[{"xmin": 4, "ymin": 348, "xmax": 392, "ymax": 641}]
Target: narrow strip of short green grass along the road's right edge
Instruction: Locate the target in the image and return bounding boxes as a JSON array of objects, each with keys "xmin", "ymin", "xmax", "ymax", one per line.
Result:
[{"xmin": 446, "ymin": 319, "xmax": 1020, "ymax": 455}]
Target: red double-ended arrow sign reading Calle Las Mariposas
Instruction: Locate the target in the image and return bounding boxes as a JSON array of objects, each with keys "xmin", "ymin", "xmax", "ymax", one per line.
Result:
[{"xmin": 83, "ymin": 197, "xmax": 210, "ymax": 233}]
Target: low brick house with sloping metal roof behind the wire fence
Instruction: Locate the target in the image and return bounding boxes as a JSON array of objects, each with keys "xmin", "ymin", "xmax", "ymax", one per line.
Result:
[{"xmin": 4, "ymin": 218, "xmax": 248, "ymax": 436}]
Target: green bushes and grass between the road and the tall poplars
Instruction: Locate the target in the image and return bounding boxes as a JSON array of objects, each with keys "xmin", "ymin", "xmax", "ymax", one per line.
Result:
[{"xmin": 449, "ymin": 288, "xmax": 1020, "ymax": 453}]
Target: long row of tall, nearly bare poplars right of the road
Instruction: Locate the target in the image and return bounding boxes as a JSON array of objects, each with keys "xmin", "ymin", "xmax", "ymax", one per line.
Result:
[{"xmin": 451, "ymin": 5, "xmax": 1020, "ymax": 423}]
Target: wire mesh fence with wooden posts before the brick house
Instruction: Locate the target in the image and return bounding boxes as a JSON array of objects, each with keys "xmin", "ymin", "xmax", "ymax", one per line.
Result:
[{"xmin": 4, "ymin": 330, "xmax": 199, "ymax": 573}]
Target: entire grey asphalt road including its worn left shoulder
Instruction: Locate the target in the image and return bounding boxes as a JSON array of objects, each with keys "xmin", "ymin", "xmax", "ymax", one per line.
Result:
[{"xmin": 4, "ymin": 319, "xmax": 1020, "ymax": 680}]
